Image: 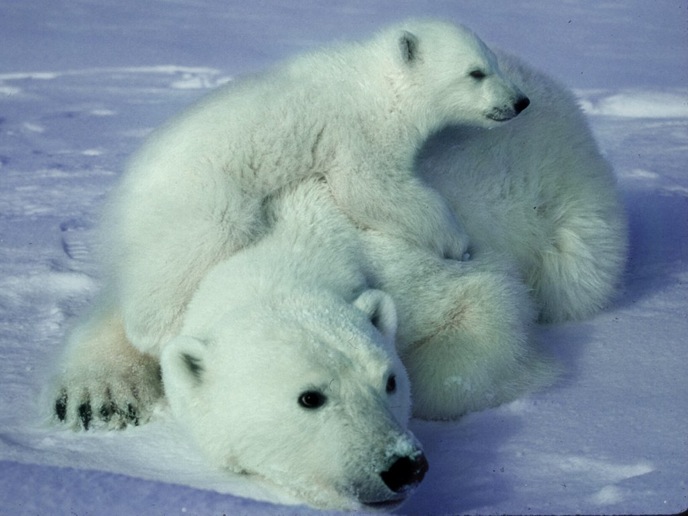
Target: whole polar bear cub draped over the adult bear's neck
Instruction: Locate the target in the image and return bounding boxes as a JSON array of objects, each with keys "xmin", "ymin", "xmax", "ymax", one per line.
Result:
[{"xmin": 98, "ymin": 21, "xmax": 529, "ymax": 354}]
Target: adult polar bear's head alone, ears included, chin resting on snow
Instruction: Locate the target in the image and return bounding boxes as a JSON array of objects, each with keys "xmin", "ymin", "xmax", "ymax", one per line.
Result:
[{"xmin": 162, "ymin": 290, "xmax": 428, "ymax": 509}]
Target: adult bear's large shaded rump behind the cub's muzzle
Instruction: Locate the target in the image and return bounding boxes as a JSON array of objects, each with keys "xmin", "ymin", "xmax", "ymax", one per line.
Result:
[{"xmin": 420, "ymin": 52, "xmax": 627, "ymax": 322}]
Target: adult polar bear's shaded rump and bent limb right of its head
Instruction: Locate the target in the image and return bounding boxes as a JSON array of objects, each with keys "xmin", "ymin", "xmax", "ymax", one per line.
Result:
[{"xmin": 364, "ymin": 51, "xmax": 628, "ymax": 419}]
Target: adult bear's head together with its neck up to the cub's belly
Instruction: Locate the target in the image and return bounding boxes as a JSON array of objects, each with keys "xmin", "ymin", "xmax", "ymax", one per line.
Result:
[{"xmin": 161, "ymin": 180, "xmax": 428, "ymax": 509}]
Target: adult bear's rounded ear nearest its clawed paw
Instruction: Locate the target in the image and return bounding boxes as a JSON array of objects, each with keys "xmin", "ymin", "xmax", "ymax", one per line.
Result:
[{"xmin": 160, "ymin": 335, "xmax": 208, "ymax": 397}]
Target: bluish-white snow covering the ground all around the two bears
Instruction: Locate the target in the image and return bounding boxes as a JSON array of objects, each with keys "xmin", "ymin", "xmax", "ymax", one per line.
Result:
[{"xmin": 0, "ymin": 0, "xmax": 688, "ymax": 514}]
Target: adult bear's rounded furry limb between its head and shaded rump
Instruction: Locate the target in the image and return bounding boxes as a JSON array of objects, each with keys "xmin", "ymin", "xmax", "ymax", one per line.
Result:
[{"xmin": 365, "ymin": 232, "xmax": 554, "ymax": 419}]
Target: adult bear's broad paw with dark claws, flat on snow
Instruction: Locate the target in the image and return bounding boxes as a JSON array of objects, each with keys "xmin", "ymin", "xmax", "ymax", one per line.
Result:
[{"xmin": 53, "ymin": 357, "xmax": 163, "ymax": 430}]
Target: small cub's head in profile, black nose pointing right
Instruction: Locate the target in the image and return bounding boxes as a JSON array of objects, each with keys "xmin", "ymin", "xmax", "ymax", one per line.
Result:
[{"xmin": 380, "ymin": 20, "xmax": 530, "ymax": 132}]
